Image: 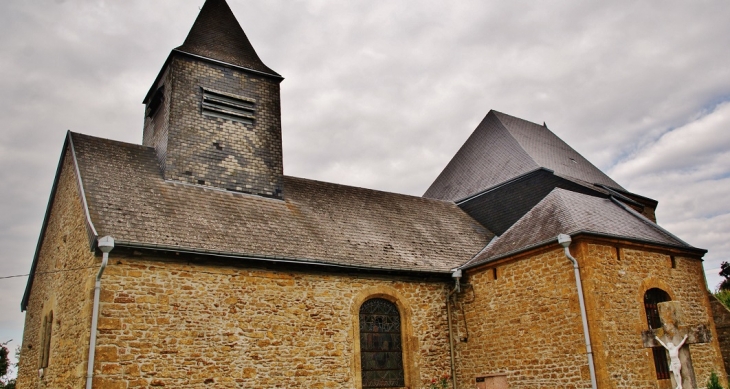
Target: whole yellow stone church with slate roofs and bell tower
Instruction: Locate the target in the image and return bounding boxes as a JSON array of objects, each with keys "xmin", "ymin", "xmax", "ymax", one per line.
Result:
[{"xmin": 17, "ymin": 0, "xmax": 730, "ymax": 389}]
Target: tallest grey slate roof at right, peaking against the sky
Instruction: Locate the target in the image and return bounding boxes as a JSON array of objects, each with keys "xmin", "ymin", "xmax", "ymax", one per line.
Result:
[{"xmin": 423, "ymin": 110, "xmax": 624, "ymax": 201}]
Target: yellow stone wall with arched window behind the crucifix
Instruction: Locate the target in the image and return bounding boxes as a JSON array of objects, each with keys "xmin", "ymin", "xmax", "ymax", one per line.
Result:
[{"xmin": 571, "ymin": 241, "xmax": 724, "ymax": 388}]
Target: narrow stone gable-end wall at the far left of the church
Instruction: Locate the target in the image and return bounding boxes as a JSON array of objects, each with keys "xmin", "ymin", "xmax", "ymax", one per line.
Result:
[{"xmin": 17, "ymin": 154, "xmax": 99, "ymax": 389}]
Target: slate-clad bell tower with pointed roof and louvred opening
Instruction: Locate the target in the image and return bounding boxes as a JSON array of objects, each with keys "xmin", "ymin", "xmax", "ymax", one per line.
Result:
[{"xmin": 143, "ymin": 0, "xmax": 283, "ymax": 199}]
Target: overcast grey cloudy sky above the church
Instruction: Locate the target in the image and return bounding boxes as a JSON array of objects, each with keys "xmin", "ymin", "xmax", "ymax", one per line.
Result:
[{"xmin": 0, "ymin": 0, "xmax": 730, "ymax": 366}]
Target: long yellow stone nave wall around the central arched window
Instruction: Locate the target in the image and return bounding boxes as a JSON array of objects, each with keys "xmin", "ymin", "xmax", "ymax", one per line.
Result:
[{"xmin": 88, "ymin": 251, "xmax": 449, "ymax": 389}]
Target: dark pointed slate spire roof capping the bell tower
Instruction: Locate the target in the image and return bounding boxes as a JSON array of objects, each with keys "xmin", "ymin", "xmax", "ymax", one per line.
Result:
[{"xmin": 175, "ymin": 0, "xmax": 280, "ymax": 77}]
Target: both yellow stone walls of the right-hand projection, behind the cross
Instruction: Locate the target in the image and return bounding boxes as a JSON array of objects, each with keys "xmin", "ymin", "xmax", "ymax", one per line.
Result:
[{"xmin": 454, "ymin": 241, "xmax": 724, "ymax": 388}]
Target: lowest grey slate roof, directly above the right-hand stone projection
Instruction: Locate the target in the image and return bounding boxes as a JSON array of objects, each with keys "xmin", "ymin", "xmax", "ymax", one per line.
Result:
[{"xmin": 465, "ymin": 188, "xmax": 704, "ymax": 267}]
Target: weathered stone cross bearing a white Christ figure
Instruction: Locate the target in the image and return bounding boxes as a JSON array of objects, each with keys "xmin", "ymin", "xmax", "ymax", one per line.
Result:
[{"xmin": 641, "ymin": 301, "xmax": 712, "ymax": 389}]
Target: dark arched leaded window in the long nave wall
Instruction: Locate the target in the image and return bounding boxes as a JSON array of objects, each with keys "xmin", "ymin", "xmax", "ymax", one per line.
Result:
[{"xmin": 360, "ymin": 298, "xmax": 405, "ymax": 389}]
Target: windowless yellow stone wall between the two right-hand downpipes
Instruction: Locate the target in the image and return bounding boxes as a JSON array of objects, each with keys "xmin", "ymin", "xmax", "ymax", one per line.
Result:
[{"xmin": 454, "ymin": 250, "xmax": 590, "ymax": 389}]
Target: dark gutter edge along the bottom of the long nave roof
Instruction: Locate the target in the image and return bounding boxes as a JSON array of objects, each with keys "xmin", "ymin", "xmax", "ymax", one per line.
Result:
[{"xmin": 114, "ymin": 240, "xmax": 451, "ymax": 275}]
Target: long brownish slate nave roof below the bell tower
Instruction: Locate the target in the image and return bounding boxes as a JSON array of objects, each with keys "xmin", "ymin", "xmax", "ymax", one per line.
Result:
[{"xmin": 70, "ymin": 133, "xmax": 493, "ymax": 272}]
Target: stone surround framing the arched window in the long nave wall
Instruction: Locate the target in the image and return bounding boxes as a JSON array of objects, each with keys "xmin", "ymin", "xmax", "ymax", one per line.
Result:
[{"xmin": 350, "ymin": 286, "xmax": 420, "ymax": 389}]
